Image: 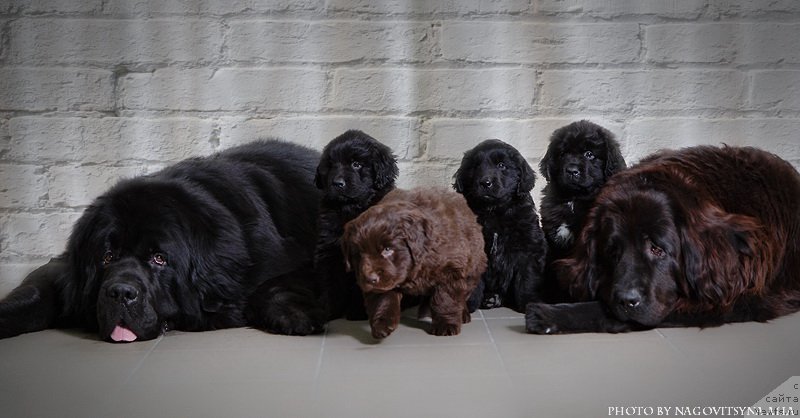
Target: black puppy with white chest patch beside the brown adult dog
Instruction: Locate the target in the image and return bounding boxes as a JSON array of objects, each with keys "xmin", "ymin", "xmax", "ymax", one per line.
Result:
[{"xmin": 539, "ymin": 120, "xmax": 625, "ymax": 260}]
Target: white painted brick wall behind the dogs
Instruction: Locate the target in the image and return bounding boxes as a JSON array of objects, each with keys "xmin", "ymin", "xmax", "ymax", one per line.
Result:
[{"xmin": 0, "ymin": 0, "xmax": 800, "ymax": 294}]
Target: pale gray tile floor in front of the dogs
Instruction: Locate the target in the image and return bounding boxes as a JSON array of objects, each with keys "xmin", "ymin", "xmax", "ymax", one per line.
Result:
[{"xmin": 0, "ymin": 309, "xmax": 800, "ymax": 418}]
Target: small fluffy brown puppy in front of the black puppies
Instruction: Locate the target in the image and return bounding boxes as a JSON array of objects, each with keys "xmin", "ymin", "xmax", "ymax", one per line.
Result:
[{"xmin": 342, "ymin": 189, "xmax": 486, "ymax": 339}]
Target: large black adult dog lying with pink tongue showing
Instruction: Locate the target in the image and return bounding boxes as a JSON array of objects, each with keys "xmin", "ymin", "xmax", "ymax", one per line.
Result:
[{"xmin": 0, "ymin": 140, "xmax": 325, "ymax": 341}]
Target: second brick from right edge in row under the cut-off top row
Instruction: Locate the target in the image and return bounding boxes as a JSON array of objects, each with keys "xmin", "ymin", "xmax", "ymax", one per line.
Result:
[{"xmin": 442, "ymin": 21, "xmax": 641, "ymax": 64}]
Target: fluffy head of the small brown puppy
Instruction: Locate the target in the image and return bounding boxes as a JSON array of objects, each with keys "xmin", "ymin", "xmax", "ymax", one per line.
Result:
[{"xmin": 342, "ymin": 202, "xmax": 430, "ymax": 293}]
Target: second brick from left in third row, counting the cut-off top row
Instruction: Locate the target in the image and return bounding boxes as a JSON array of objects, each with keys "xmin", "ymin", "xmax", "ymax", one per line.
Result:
[{"xmin": 120, "ymin": 68, "xmax": 327, "ymax": 112}]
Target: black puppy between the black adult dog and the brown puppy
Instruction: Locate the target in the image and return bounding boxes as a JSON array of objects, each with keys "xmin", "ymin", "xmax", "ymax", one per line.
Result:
[{"xmin": 314, "ymin": 130, "xmax": 399, "ymax": 320}]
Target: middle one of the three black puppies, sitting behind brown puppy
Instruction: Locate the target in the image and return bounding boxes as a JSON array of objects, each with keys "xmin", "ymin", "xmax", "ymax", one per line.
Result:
[{"xmin": 453, "ymin": 139, "xmax": 547, "ymax": 312}]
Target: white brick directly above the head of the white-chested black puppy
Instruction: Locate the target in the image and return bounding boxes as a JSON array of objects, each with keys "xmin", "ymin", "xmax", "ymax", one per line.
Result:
[{"xmin": 540, "ymin": 70, "xmax": 746, "ymax": 111}]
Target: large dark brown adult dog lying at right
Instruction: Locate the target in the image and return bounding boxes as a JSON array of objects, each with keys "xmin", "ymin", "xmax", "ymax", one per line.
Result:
[{"xmin": 526, "ymin": 146, "xmax": 800, "ymax": 334}]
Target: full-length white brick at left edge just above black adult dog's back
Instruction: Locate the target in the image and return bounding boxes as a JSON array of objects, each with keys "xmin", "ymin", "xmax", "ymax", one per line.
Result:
[{"xmin": 7, "ymin": 116, "xmax": 215, "ymax": 164}]
